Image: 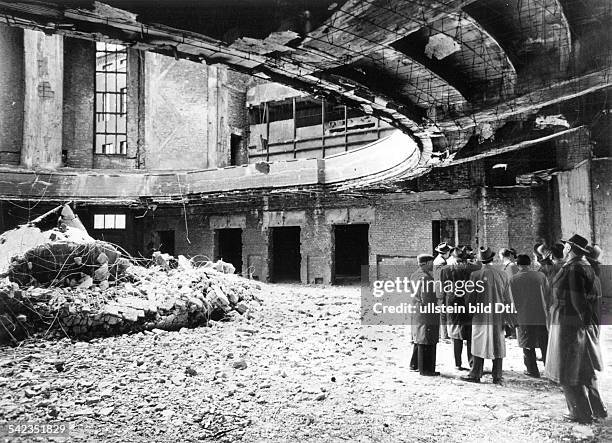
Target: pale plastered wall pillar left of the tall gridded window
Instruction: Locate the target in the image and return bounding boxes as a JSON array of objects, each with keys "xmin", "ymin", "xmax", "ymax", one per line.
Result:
[{"xmin": 21, "ymin": 30, "xmax": 64, "ymax": 169}]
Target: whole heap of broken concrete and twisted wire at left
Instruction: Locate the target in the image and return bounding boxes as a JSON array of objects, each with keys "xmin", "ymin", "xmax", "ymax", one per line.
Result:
[{"xmin": 0, "ymin": 205, "xmax": 259, "ymax": 344}]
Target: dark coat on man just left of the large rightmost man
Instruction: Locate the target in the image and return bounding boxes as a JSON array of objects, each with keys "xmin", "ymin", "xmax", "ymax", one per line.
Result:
[{"xmin": 508, "ymin": 269, "xmax": 548, "ymax": 349}]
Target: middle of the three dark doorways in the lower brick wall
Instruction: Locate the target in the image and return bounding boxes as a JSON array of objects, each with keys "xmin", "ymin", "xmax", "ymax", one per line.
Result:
[{"xmin": 271, "ymin": 226, "xmax": 302, "ymax": 282}]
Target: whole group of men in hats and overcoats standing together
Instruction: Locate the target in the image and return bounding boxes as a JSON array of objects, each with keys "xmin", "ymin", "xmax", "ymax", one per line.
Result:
[{"xmin": 410, "ymin": 235, "xmax": 607, "ymax": 423}]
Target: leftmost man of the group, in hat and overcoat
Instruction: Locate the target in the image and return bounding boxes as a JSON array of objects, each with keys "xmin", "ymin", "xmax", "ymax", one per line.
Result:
[{"xmin": 410, "ymin": 254, "xmax": 440, "ymax": 376}]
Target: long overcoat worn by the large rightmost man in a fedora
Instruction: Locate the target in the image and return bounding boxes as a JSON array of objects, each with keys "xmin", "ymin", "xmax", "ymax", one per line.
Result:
[{"xmin": 545, "ymin": 257, "xmax": 603, "ymax": 386}]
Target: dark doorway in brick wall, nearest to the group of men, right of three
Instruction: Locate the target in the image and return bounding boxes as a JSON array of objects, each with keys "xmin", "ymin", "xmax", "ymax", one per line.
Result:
[{"xmin": 334, "ymin": 224, "xmax": 369, "ymax": 284}]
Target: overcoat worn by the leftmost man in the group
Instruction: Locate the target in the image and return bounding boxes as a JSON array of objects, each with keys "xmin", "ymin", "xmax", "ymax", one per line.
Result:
[{"xmin": 410, "ymin": 269, "xmax": 440, "ymax": 345}]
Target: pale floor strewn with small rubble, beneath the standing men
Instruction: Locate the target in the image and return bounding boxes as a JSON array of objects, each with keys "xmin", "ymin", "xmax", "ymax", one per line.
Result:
[{"xmin": 0, "ymin": 285, "xmax": 612, "ymax": 442}]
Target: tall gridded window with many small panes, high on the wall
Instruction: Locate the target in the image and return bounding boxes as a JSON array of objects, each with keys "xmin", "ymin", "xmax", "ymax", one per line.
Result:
[{"xmin": 95, "ymin": 42, "xmax": 127, "ymax": 155}]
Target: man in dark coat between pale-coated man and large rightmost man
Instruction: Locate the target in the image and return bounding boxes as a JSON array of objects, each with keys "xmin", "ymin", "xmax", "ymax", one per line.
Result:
[{"xmin": 508, "ymin": 255, "xmax": 548, "ymax": 378}]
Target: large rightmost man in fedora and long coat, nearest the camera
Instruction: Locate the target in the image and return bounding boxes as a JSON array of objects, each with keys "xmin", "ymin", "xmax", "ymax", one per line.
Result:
[{"xmin": 545, "ymin": 234, "xmax": 608, "ymax": 423}]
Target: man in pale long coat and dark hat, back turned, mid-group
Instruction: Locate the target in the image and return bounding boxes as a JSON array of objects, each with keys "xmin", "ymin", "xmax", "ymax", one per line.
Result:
[{"xmin": 461, "ymin": 247, "xmax": 511, "ymax": 384}]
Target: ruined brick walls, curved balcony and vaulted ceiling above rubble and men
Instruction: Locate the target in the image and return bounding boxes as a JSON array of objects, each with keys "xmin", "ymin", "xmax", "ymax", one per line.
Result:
[{"xmin": 0, "ymin": 0, "xmax": 612, "ymax": 285}]
